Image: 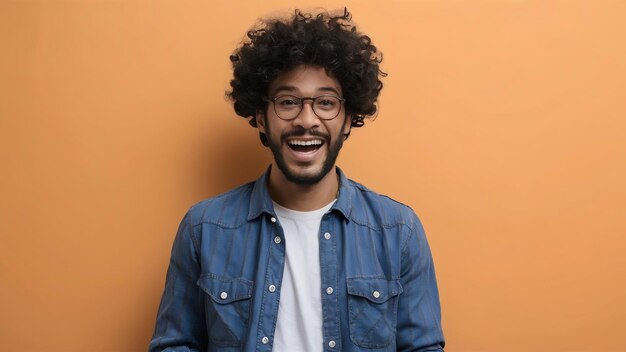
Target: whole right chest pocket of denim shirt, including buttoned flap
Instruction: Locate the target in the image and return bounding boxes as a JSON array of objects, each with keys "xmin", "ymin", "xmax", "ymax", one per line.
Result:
[{"xmin": 346, "ymin": 278, "xmax": 402, "ymax": 348}]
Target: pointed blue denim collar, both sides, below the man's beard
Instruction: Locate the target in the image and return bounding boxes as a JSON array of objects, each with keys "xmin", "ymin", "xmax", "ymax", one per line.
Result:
[{"xmin": 248, "ymin": 166, "xmax": 352, "ymax": 221}]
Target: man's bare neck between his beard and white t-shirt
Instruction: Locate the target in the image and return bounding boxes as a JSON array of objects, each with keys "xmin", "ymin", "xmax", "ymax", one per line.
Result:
[{"xmin": 268, "ymin": 164, "xmax": 339, "ymax": 211}]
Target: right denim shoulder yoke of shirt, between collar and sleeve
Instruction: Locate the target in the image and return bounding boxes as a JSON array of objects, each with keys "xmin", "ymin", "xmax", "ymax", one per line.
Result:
[{"xmin": 347, "ymin": 179, "xmax": 421, "ymax": 229}]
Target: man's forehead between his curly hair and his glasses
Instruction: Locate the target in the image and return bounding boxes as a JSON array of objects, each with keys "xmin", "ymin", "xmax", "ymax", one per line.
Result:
[{"xmin": 269, "ymin": 65, "xmax": 342, "ymax": 96}]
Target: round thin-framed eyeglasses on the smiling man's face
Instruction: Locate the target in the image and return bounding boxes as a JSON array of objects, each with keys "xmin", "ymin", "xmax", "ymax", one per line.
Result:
[{"xmin": 265, "ymin": 95, "xmax": 346, "ymax": 121}]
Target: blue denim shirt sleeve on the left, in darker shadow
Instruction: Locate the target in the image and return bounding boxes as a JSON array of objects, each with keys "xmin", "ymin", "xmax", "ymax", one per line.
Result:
[{"xmin": 149, "ymin": 213, "xmax": 207, "ymax": 352}]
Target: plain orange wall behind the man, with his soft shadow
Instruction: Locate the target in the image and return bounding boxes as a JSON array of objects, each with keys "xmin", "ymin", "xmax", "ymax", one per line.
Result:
[{"xmin": 0, "ymin": 0, "xmax": 626, "ymax": 352}]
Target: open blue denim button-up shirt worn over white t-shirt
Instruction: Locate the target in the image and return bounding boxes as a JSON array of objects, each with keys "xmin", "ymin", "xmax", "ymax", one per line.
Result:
[{"xmin": 149, "ymin": 168, "xmax": 444, "ymax": 352}]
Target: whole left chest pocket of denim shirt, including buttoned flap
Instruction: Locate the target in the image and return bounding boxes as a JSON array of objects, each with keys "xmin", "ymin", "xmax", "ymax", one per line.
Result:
[{"xmin": 197, "ymin": 274, "xmax": 253, "ymax": 347}]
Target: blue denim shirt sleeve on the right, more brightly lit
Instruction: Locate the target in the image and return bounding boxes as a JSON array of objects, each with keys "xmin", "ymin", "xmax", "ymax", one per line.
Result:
[{"xmin": 396, "ymin": 215, "xmax": 445, "ymax": 352}]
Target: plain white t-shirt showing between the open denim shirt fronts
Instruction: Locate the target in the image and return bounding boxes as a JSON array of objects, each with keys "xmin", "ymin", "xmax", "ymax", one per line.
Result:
[{"xmin": 272, "ymin": 200, "xmax": 335, "ymax": 352}]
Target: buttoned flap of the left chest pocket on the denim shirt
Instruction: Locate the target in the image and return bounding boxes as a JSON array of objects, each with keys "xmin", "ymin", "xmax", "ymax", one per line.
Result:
[{"xmin": 197, "ymin": 274, "xmax": 252, "ymax": 304}]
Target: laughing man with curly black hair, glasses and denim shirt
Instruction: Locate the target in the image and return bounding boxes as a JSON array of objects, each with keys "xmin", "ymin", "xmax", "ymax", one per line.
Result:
[{"xmin": 150, "ymin": 11, "xmax": 444, "ymax": 351}]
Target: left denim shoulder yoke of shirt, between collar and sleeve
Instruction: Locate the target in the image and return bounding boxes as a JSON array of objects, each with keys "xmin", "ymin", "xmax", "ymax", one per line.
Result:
[{"xmin": 186, "ymin": 182, "xmax": 254, "ymax": 228}]
